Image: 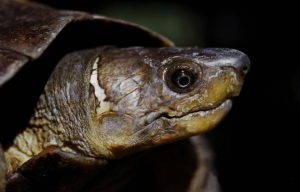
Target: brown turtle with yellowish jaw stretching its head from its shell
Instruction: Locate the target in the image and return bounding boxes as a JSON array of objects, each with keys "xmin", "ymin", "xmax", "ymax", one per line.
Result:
[{"xmin": 0, "ymin": 0, "xmax": 250, "ymax": 192}]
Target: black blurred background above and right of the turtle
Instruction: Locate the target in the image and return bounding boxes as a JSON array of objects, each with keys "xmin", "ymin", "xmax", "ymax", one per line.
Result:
[{"xmin": 31, "ymin": 0, "xmax": 300, "ymax": 192}]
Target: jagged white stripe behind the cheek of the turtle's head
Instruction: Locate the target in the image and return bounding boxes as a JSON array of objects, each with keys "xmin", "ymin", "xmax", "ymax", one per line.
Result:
[{"xmin": 90, "ymin": 57, "xmax": 111, "ymax": 115}]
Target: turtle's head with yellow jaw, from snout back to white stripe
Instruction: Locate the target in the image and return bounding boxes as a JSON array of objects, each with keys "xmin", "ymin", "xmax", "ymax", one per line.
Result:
[{"xmin": 88, "ymin": 47, "xmax": 250, "ymax": 158}]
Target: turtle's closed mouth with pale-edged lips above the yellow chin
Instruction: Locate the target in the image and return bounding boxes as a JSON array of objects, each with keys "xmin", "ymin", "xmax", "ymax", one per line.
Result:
[{"xmin": 145, "ymin": 99, "xmax": 232, "ymax": 125}]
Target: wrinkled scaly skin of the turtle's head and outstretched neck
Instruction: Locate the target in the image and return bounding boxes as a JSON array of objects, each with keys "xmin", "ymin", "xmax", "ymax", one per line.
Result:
[{"xmin": 5, "ymin": 47, "xmax": 249, "ymax": 176}]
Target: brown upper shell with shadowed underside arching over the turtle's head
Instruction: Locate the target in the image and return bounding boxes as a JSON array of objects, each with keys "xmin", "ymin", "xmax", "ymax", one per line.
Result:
[{"xmin": 0, "ymin": 0, "xmax": 173, "ymax": 85}]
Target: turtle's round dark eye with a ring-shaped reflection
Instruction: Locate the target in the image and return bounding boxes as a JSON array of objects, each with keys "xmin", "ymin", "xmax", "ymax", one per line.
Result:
[{"xmin": 164, "ymin": 62, "xmax": 201, "ymax": 93}]
